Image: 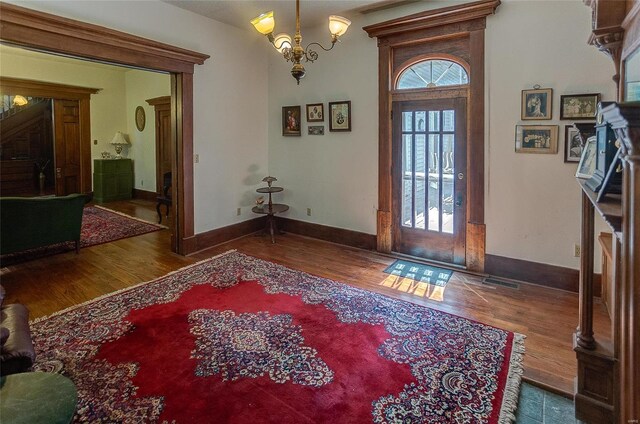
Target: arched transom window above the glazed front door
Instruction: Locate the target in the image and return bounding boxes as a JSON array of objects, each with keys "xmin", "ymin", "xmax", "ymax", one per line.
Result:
[{"xmin": 396, "ymin": 59, "xmax": 469, "ymax": 89}]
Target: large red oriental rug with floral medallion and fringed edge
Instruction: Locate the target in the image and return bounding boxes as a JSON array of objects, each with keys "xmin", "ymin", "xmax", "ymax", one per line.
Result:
[{"xmin": 32, "ymin": 251, "xmax": 524, "ymax": 424}]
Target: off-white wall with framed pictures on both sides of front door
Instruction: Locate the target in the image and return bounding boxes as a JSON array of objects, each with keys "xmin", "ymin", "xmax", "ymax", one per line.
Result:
[{"xmin": 264, "ymin": 0, "xmax": 615, "ymax": 268}]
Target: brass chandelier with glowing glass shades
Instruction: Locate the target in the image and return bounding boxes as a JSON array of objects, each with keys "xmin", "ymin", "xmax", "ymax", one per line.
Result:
[{"xmin": 251, "ymin": 0, "xmax": 351, "ymax": 85}]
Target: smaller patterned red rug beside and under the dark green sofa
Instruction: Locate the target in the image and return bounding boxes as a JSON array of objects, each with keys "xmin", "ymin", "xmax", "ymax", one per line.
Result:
[{"xmin": 0, "ymin": 206, "xmax": 166, "ymax": 267}]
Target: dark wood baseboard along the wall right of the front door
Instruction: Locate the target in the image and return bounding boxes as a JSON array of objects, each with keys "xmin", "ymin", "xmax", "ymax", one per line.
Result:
[{"xmin": 484, "ymin": 255, "xmax": 601, "ymax": 296}]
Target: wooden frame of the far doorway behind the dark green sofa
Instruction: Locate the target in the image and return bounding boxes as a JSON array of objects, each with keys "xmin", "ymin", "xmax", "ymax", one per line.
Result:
[{"xmin": 0, "ymin": 77, "xmax": 100, "ymax": 193}]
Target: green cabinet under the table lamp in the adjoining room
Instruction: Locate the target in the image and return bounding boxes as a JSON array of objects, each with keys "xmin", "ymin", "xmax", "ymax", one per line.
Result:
[{"xmin": 93, "ymin": 159, "xmax": 133, "ymax": 203}]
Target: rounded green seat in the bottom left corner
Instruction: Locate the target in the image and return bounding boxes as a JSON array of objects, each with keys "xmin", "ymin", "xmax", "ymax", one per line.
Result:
[{"xmin": 0, "ymin": 372, "xmax": 78, "ymax": 424}]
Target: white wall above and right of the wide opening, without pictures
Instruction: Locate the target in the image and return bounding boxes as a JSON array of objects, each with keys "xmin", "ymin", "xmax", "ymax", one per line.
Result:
[{"xmin": 11, "ymin": 1, "xmax": 268, "ymax": 233}]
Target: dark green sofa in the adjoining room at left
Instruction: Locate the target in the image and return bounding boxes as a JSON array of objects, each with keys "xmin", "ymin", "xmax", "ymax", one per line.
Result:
[{"xmin": 0, "ymin": 194, "xmax": 86, "ymax": 255}]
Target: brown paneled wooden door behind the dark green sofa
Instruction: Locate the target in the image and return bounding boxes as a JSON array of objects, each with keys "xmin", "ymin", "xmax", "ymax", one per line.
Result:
[{"xmin": 53, "ymin": 99, "xmax": 81, "ymax": 196}]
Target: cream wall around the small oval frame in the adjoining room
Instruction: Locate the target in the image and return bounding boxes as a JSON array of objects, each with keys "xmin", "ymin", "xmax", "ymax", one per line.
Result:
[{"xmin": 125, "ymin": 69, "xmax": 171, "ymax": 192}]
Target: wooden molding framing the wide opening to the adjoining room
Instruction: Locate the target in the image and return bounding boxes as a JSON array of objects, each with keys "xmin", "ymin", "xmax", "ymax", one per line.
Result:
[{"xmin": 0, "ymin": 2, "xmax": 209, "ymax": 255}]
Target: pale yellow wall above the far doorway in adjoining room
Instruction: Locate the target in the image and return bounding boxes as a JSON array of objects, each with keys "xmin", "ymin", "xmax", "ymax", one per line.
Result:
[{"xmin": 0, "ymin": 48, "xmax": 127, "ymax": 158}]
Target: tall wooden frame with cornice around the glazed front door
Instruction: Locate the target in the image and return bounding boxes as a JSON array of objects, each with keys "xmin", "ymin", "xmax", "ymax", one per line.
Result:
[{"xmin": 363, "ymin": 0, "xmax": 500, "ymax": 272}]
